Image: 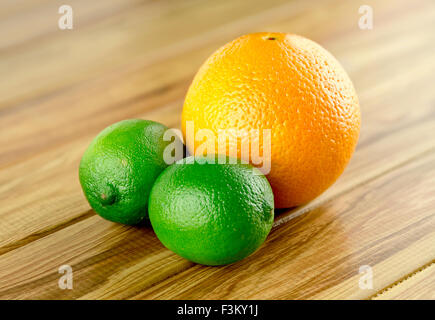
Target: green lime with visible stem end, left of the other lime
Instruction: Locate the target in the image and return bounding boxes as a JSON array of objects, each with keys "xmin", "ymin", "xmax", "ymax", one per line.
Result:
[{"xmin": 79, "ymin": 119, "xmax": 180, "ymax": 224}]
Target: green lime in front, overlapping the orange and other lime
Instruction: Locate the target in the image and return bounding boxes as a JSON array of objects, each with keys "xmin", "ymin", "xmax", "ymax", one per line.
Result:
[{"xmin": 149, "ymin": 157, "xmax": 274, "ymax": 265}]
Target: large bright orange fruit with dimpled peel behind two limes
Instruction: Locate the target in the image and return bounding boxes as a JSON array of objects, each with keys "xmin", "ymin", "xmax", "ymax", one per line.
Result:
[{"xmin": 182, "ymin": 33, "xmax": 361, "ymax": 208}]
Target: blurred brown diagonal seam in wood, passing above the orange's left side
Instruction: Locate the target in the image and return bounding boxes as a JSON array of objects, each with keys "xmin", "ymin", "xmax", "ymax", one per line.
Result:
[{"xmin": 0, "ymin": 3, "xmax": 314, "ymax": 110}]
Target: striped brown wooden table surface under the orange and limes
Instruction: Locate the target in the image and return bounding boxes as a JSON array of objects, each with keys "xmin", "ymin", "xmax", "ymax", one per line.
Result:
[{"xmin": 0, "ymin": 0, "xmax": 435, "ymax": 299}]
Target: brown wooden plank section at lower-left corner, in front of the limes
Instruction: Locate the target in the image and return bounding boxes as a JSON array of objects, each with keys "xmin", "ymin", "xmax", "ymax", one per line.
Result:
[{"xmin": 0, "ymin": 212, "xmax": 192, "ymax": 299}]
